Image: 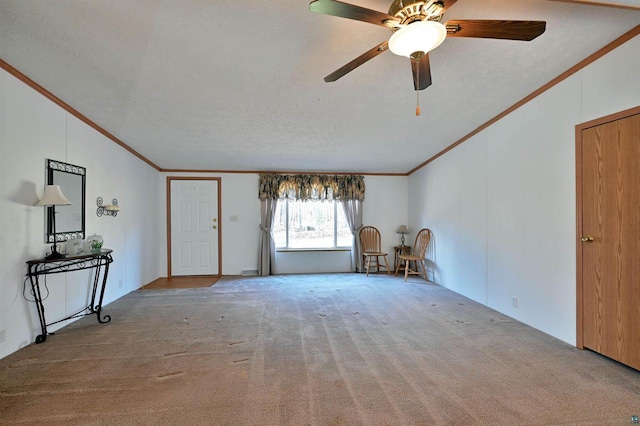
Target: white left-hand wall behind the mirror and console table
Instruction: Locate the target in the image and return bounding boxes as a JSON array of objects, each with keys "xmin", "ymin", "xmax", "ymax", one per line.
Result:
[{"xmin": 0, "ymin": 70, "xmax": 159, "ymax": 358}]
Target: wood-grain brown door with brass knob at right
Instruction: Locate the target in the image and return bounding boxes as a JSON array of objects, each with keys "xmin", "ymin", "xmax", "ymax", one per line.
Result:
[{"xmin": 578, "ymin": 109, "xmax": 640, "ymax": 369}]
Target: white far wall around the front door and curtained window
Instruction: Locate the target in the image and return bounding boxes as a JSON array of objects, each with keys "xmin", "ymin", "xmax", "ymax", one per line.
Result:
[{"xmin": 157, "ymin": 173, "xmax": 408, "ymax": 276}]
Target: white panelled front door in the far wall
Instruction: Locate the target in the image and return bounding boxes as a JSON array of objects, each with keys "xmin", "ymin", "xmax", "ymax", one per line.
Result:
[{"xmin": 170, "ymin": 179, "xmax": 220, "ymax": 276}]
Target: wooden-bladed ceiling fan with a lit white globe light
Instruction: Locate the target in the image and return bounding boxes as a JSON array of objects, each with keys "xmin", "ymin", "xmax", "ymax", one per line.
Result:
[{"xmin": 309, "ymin": 0, "xmax": 546, "ymax": 93}]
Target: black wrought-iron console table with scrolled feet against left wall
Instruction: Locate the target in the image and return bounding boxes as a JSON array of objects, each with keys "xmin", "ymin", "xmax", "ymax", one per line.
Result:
[{"xmin": 27, "ymin": 249, "xmax": 113, "ymax": 343}]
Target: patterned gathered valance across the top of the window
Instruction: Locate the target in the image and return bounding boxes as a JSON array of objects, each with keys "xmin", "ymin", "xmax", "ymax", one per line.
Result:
[{"xmin": 258, "ymin": 174, "xmax": 364, "ymax": 201}]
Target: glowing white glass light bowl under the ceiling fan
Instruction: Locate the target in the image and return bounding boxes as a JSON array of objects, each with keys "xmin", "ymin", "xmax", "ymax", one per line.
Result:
[{"xmin": 389, "ymin": 21, "xmax": 447, "ymax": 58}]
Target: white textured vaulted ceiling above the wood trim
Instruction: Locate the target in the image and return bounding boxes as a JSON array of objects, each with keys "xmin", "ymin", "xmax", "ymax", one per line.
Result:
[{"xmin": 0, "ymin": 0, "xmax": 640, "ymax": 173}]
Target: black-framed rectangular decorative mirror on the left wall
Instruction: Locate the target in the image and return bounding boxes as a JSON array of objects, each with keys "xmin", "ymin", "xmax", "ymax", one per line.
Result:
[{"xmin": 45, "ymin": 159, "xmax": 87, "ymax": 243}]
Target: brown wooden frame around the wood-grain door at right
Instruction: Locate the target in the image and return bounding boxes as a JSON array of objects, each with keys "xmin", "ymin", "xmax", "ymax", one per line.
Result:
[{"xmin": 576, "ymin": 106, "xmax": 640, "ymax": 349}]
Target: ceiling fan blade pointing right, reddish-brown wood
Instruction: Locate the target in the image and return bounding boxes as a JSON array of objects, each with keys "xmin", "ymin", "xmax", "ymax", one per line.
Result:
[{"xmin": 445, "ymin": 20, "xmax": 547, "ymax": 41}]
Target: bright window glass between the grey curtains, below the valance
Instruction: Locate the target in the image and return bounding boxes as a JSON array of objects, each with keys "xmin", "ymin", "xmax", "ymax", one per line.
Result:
[{"xmin": 273, "ymin": 199, "xmax": 353, "ymax": 249}]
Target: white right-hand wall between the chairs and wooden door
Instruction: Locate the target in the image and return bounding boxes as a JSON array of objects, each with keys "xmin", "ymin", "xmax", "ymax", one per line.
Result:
[{"xmin": 409, "ymin": 37, "xmax": 640, "ymax": 344}]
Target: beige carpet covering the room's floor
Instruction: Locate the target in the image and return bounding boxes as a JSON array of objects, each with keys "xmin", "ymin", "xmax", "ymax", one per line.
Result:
[{"xmin": 0, "ymin": 274, "xmax": 640, "ymax": 425}]
